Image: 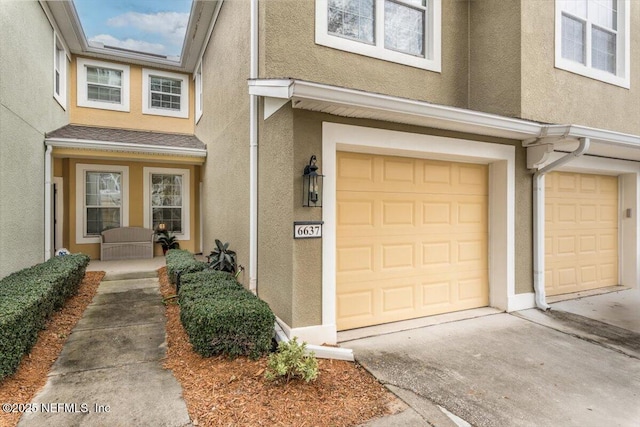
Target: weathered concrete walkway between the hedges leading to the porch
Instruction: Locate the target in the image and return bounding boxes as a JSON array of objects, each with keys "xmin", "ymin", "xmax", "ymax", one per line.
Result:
[{"xmin": 18, "ymin": 271, "xmax": 190, "ymax": 427}]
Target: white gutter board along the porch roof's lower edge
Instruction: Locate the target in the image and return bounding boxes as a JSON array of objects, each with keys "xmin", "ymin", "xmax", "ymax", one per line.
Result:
[{"xmin": 45, "ymin": 138, "xmax": 207, "ymax": 158}]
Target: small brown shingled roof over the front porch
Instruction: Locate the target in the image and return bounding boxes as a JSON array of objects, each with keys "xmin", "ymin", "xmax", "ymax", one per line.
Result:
[{"xmin": 46, "ymin": 125, "xmax": 206, "ymax": 150}]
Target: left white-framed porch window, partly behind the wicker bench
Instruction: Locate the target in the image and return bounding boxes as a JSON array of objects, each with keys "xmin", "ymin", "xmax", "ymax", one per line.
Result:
[{"xmin": 76, "ymin": 164, "xmax": 129, "ymax": 243}]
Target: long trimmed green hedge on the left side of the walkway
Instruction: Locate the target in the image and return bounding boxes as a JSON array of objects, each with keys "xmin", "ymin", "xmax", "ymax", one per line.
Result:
[{"xmin": 0, "ymin": 254, "xmax": 89, "ymax": 380}]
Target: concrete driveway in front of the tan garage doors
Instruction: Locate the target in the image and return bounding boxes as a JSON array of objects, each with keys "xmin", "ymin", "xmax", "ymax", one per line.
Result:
[{"xmin": 350, "ymin": 290, "xmax": 640, "ymax": 427}]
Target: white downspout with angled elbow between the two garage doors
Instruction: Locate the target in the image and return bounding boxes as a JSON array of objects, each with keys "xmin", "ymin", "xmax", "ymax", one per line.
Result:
[{"xmin": 533, "ymin": 138, "xmax": 590, "ymax": 311}]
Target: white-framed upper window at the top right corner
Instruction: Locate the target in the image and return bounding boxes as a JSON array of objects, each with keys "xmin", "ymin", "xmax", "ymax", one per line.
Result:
[{"xmin": 555, "ymin": 0, "xmax": 630, "ymax": 88}]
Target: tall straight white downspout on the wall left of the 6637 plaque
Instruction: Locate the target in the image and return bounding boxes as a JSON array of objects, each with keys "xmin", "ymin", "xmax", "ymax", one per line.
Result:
[{"xmin": 249, "ymin": 0, "xmax": 258, "ymax": 294}]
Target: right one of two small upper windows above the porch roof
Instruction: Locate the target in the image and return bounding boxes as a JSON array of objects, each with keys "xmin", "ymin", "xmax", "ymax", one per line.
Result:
[{"xmin": 142, "ymin": 69, "xmax": 189, "ymax": 118}]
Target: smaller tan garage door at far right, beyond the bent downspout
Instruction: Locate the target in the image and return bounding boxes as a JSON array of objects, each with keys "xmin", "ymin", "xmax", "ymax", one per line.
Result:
[{"xmin": 545, "ymin": 172, "xmax": 618, "ymax": 295}]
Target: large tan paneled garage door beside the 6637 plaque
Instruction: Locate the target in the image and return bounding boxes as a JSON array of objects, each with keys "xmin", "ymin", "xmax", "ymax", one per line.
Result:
[{"xmin": 336, "ymin": 153, "xmax": 489, "ymax": 330}]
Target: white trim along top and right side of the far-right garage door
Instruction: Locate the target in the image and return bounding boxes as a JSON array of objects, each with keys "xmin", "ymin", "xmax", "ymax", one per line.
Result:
[{"xmin": 543, "ymin": 153, "xmax": 640, "ymax": 288}]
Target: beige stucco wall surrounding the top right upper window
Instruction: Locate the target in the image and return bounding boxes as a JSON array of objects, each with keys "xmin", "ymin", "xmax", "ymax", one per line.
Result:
[{"xmin": 521, "ymin": 1, "xmax": 640, "ymax": 135}]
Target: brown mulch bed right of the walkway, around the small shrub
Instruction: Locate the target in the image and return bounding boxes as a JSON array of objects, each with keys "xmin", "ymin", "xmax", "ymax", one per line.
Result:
[{"xmin": 158, "ymin": 267, "xmax": 395, "ymax": 426}]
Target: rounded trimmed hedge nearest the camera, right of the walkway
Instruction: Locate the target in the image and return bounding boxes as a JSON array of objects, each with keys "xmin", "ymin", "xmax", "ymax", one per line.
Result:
[{"xmin": 179, "ymin": 270, "xmax": 275, "ymax": 359}]
